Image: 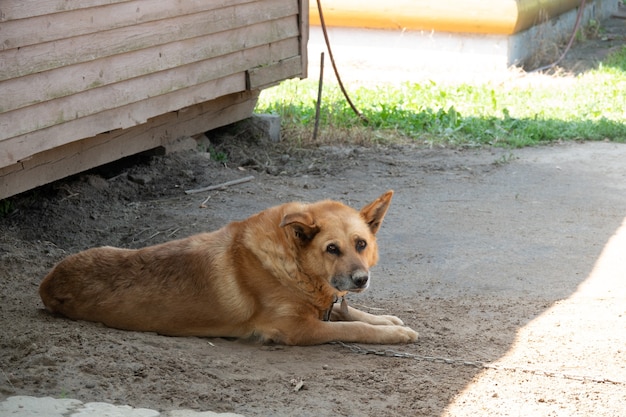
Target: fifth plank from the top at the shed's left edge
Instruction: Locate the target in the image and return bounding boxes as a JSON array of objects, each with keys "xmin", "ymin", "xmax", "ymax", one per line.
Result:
[{"xmin": 0, "ymin": 28, "xmax": 297, "ymax": 142}]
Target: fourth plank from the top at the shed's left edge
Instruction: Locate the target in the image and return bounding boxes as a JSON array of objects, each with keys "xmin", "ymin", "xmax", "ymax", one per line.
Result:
[{"xmin": 0, "ymin": 18, "xmax": 298, "ymax": 113}]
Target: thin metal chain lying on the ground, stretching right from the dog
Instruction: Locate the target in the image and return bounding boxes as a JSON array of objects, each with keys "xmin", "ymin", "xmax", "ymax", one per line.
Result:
[{"xmin": 332, "ymin": 342, "xmax": 626, "ymax": 385}]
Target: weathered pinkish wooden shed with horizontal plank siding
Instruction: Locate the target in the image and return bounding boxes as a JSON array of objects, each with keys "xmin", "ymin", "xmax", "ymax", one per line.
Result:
[{"xmin": 0, "ymin": 0, "xmax": 309, "ymax": 199}]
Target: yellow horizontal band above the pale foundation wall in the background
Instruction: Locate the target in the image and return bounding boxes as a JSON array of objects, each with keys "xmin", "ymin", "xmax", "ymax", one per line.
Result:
[{"xmin": 309, "ymin": 0, "xmax": 581, "ymax": 35}]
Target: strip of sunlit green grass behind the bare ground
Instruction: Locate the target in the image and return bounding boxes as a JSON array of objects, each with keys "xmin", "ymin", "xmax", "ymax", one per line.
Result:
[{"xmin": 256, "ymin": 47, "xmax": 626, "ymax": 147}]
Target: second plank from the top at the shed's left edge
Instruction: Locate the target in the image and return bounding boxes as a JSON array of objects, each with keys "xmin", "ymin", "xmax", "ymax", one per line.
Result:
[{"xmin": 0, "ymin": 0, "xmax": 255, "ymax": 50}]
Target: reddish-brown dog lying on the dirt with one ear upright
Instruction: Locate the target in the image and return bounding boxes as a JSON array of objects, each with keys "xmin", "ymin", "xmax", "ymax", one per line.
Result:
[{"xmin": 39, "ymin": 191, "xmax": 417, "ymax": 345}]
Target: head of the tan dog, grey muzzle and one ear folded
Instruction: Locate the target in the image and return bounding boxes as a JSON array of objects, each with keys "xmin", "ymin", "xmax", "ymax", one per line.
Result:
[{"xmin": 280, "ymin": 191, "xmax": 393, "ymax": 295}]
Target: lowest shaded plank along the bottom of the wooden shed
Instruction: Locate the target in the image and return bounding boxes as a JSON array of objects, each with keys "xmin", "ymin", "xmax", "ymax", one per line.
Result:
[{"xmin": 0, "ymin": 91, "xmax": 258, "ymax": 199}]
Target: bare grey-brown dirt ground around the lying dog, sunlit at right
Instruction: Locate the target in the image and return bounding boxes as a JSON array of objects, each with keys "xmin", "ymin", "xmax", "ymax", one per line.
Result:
[{"xmin": 0, "ymin": 11, "xmax": 626, "ymax": 416}]
